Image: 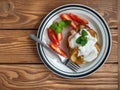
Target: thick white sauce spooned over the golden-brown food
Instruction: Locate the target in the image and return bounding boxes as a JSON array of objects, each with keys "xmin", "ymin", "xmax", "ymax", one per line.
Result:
[{"xmin": 68, "ymin": 29, "xmax": 98, "ymax": 62}]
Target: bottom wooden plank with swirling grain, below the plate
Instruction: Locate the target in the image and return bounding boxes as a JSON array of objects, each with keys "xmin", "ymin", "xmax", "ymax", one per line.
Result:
[{"xmin": 0, "ymin": 64, "xmax": 118, "ymax": 90}]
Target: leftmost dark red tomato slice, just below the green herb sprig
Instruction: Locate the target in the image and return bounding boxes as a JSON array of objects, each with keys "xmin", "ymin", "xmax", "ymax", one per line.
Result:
[{"xmin": 48, "ymin": 29, "xmax": 60, "ymax": 46}]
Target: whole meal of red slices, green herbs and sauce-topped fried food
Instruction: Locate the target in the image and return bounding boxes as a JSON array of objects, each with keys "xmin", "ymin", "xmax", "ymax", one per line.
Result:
[{"xmin": 48, "ymin": 13, "xmax": 101, "ymax": 64}]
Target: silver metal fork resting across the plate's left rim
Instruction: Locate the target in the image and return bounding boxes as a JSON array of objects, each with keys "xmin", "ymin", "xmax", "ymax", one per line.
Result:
[{"xmin": 30, "ymin": 34, "xmax": 80, "ymax": 72}]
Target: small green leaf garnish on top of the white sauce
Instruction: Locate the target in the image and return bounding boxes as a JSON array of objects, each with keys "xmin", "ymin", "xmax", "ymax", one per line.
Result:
[{"xmin": 76, "ymin": 30, "xmax": 88, "ymax": 46}]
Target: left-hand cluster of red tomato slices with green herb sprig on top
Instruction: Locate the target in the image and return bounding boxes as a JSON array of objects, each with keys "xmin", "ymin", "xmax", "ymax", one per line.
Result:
[{"xmin": 48, "ymin": 20, "xmax": 71, "ymax": 57}]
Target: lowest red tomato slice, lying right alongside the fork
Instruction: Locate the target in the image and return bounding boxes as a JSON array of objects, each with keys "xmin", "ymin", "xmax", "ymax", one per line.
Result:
[{"xmin": 49, "ymin": 43, "xmax": 68, "ymax": 58}]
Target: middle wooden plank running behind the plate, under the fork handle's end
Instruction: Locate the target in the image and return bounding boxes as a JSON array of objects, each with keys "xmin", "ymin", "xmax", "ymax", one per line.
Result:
[{"xmin": 0, "ymin": 29, "xmax": 118, "ymax": 63}]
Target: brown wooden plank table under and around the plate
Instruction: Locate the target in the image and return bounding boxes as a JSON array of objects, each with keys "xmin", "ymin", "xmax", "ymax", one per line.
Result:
[{"xmin": 0, "ymin": 0, "xmax": 120, "ymax": 90}]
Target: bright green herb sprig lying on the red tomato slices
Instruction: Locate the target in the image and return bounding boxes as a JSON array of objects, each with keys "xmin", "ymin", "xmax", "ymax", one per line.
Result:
[{"xmin": 50, "ymin": 20, "xmax": 71, "ymax": 34}]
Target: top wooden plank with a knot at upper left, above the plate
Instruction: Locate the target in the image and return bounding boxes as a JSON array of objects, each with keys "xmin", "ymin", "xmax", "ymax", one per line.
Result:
[{"xmin": 0, "ymin": 0, "xmax": 117, "ymax": 29}]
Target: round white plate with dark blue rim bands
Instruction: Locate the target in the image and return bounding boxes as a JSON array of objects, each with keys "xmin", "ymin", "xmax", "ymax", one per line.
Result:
[{"xmin": 37, "ymin": 4, "xmax": 111, "ymax": 78}]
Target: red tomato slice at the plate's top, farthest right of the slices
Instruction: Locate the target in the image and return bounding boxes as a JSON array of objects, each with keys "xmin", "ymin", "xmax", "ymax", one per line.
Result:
[{"xmin": 69, "ymin": 13, "xmax": 88, "ymax": 25}]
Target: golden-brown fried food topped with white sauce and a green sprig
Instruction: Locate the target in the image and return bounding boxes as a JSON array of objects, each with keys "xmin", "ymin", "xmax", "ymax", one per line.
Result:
[{"xmin": 68, "ymin": 25, "xmax": 100, "ymax": 64}]
